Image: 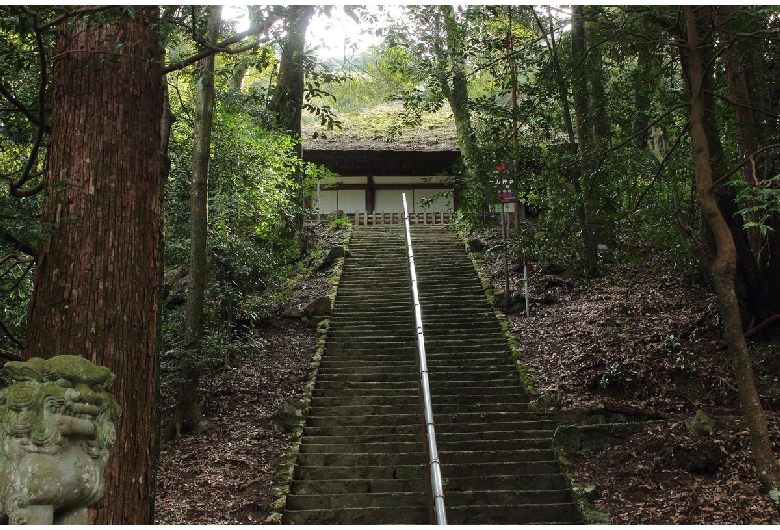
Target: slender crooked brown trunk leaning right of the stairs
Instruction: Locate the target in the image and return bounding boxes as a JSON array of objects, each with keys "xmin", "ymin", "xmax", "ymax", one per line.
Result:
[{"xmin": 683, "ymin": 6, "xmax": 780, "ymax": 503}]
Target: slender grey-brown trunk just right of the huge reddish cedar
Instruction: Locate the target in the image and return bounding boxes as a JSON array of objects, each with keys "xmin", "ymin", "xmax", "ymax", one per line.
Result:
[{"xmin": 176, "ymin": 5, "xmax": 222, "ymax": 434}]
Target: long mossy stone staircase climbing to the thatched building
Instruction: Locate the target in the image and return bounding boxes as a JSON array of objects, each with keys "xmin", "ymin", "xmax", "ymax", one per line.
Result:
[{"xmin": 282, "ymin": 225, "xmax": 580, "ymax": 524}]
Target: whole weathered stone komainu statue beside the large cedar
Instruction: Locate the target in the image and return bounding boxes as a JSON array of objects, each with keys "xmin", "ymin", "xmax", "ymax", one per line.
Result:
[{"xmin": 0, "ymin": 355, "xmax": 119, "ymax": 524}]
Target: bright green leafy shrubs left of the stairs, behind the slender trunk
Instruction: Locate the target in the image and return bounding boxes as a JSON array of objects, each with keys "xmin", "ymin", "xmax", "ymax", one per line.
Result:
[{"xmin": 166, "ymin": 80, "xmax": 301, "ymax": 321}]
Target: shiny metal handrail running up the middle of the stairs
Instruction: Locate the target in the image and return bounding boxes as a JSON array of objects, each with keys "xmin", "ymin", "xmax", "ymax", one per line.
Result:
[{"xmin": 401, "ymin": 193, "xmax": 447, "ymax": 525}]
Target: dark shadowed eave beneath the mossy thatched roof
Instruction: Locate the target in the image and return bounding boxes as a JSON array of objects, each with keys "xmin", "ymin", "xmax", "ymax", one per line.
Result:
[{"xmin": 303, "ymin": 148, "xmax": 460, "ymax": 177}]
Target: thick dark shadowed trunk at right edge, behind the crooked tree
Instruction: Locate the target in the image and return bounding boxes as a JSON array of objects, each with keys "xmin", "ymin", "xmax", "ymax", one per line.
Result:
[{"xmin": 714, "ymin": 6, "xmax": 780, "ymax": 322}]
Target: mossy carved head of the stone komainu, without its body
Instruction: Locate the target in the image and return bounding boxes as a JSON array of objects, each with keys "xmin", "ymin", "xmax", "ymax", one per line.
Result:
[{"xmin": 0, "ymin": 355, "xmax": 119, "ymax": 458}]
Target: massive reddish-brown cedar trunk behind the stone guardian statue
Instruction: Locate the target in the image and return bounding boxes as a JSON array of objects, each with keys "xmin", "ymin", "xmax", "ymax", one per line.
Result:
[{"xmin": 25, "ymin": 8, "xmax": 162, "ymax": 524}]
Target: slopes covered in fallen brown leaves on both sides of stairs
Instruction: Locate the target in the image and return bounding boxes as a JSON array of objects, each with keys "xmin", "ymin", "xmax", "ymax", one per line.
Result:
[{"xmin": 155, "ymin": 221, "xmax": 780, "ymax": 524}]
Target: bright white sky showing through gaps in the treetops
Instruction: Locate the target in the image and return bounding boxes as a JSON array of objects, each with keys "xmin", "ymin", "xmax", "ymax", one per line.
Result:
[{"xmin": 222, "ymin": 5, "xmax": 397, "ymax": 59}]
